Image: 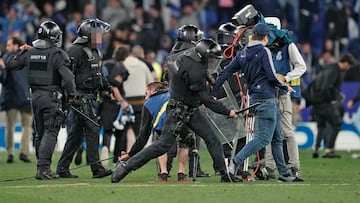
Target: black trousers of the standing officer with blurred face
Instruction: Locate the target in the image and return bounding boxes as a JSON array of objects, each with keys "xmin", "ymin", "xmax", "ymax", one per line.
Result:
[{"xmin": 57, "ymin": 102, "xmax": 104, "ymax": 173}]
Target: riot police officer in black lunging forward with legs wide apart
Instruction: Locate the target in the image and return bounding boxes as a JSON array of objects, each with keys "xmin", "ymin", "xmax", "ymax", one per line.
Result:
[{"xmin": 111, "ymin": 39, "xmax": 237, "ymax": 183}]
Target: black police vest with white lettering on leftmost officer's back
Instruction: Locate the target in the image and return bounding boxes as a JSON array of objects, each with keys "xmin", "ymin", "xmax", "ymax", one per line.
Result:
[{"xmin": 28, "ymin": 47, "xmax": 61, "ymax": 86}]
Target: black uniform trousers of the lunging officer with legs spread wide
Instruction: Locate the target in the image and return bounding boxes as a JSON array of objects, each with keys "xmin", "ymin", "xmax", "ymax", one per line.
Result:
[{"xmin": 127, "ymin": 105, "xmax": 226, "ymax": 174}]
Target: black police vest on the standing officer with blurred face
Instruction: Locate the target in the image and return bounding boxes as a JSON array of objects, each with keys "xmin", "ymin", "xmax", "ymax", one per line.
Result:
[{"xmin": 75, "ymin": 47, "xmax": 104, "ymax": 90}]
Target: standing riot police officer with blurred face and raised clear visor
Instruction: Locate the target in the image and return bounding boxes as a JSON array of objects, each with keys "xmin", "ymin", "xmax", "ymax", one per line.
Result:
[{"xmin": 57, "ymin": 19, "xmax": 112, "ymax": 178}]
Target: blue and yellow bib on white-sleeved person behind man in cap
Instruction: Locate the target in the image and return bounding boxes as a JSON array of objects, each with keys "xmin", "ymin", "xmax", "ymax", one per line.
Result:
[{"xmin": 272, "ymin": 45, "xmax": 301, "ymax": 98}]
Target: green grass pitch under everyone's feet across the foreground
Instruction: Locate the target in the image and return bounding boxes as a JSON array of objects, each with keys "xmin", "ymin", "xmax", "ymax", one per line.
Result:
[{"xmin": 0, "ymin": 150, "xmax": 360, "ymax": 203}]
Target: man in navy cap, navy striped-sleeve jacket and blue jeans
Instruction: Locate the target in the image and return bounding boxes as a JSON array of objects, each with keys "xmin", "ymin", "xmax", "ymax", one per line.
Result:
[{"xmin": 213, "ymin": 23, "xmax": 296, "ymax": 182}]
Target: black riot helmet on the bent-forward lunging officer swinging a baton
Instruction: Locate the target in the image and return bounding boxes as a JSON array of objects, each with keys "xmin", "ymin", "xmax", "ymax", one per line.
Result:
[{"xmin": 185, "ymin": 39, "xmax": 222, "ymax": 62}]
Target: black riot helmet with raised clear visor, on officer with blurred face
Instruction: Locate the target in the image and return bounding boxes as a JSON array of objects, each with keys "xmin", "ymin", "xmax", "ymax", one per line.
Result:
[{"xmin": 74, "ymin": 18, "xmax": 111, "ymax": 44}]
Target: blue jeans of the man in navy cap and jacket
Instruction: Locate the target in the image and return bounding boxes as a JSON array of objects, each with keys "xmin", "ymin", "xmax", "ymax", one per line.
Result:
[{"xmin": 233, "ymin": 98, "xmax": 288, "ymax": 174}]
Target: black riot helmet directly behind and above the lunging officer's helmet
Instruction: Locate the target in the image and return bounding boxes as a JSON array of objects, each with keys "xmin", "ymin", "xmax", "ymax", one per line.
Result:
[{"xmin": 177, "ymin": 25, "xmax": 204, "ymax": 43}]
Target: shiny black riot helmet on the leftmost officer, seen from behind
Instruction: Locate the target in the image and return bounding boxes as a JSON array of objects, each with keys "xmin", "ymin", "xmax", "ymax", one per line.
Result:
[{"xmin": 38, "ymin": 21, "xmax": 62, "ymax": 47}]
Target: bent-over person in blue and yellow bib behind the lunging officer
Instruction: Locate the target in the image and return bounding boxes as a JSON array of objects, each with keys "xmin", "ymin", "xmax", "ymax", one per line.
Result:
[{"xmin": 120, "ymin": 82, "xmax": 192, "ymax": 181}]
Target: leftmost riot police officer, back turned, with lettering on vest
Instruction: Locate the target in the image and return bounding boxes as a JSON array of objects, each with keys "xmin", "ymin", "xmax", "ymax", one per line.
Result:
[{"xmin": 7, "ymin": 21, "xmax": 77, "ymax": 180}]
